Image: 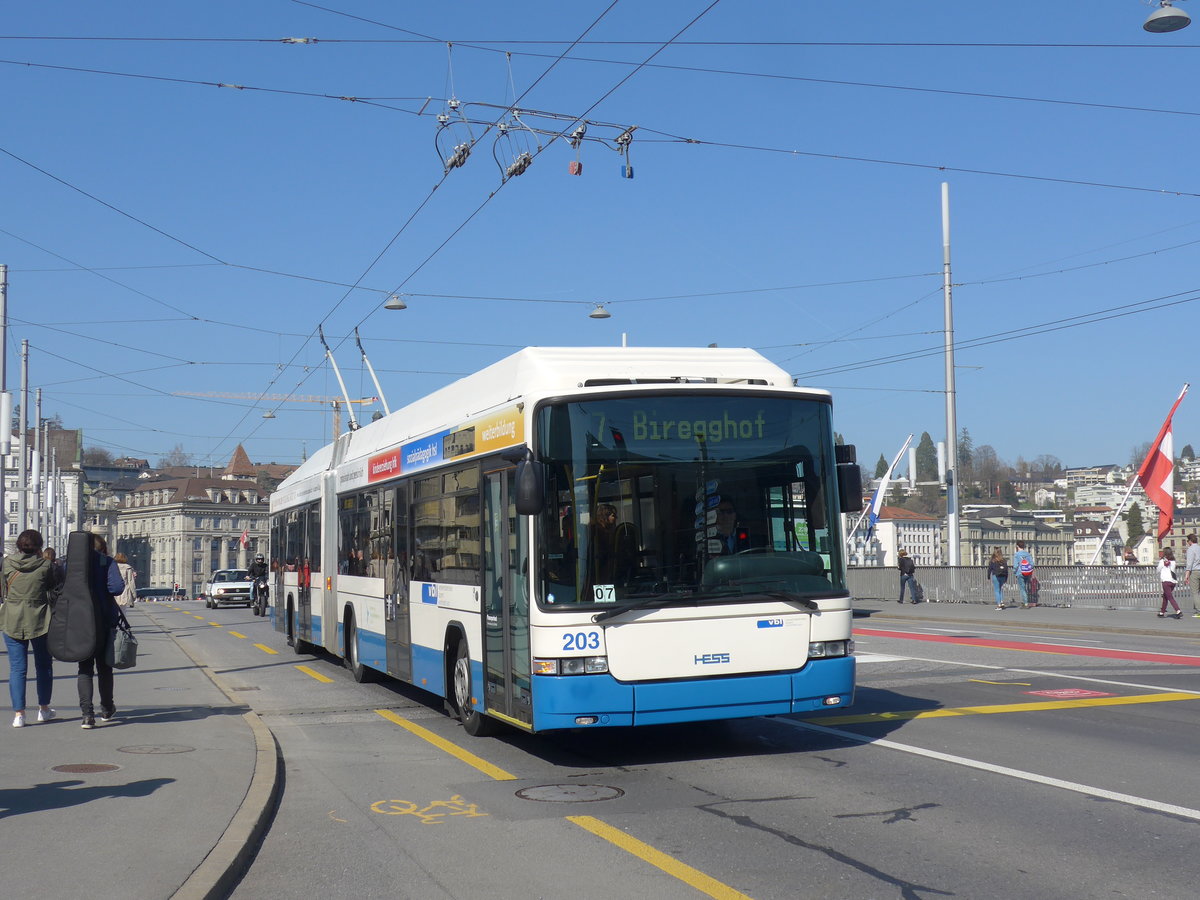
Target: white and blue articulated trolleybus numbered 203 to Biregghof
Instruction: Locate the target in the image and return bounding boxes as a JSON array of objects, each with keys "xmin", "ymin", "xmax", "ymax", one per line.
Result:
[{"xmin": 271, "ymin": 347, "xmax": 862, "ymax": 734}]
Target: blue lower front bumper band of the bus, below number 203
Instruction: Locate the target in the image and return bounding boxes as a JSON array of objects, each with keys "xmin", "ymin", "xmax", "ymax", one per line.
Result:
[{"xmin": 533, "ymin": 656, "xmax": 854, "ymax": 731}]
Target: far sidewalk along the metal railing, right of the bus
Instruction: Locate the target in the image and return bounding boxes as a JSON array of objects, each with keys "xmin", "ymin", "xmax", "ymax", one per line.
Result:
[{"xmin": 854, "ymin": 600, "xmax": 1200, "ymax": 638}]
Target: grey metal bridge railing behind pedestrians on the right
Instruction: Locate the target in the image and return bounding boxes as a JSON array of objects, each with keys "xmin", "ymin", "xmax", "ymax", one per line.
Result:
[{"xmin": 846, "ymin": 565, "xmax": 1195, "ymax": 610}]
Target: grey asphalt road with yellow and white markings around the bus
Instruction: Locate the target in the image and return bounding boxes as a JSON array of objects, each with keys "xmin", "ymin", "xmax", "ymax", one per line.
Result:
[{"xmin": 151, "ymin": 604, "xmax": 1200, "ymax": 900}]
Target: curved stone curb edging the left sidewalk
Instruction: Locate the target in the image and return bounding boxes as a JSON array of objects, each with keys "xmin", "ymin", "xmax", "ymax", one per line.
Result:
[{"xmin": 144, "ymin": 607, "xmax": 283, "ymax": 900}]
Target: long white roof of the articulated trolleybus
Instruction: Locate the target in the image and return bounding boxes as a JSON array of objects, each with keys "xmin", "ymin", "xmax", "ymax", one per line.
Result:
[{"xmin": 271, "ymin": 347, "xmax": 829, "ymax": 509}]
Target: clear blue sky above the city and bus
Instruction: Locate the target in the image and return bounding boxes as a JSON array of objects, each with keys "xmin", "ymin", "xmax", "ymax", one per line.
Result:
[{"xmin": 0, "ymin": 0, "xmax": 1200, "ymax": 467}]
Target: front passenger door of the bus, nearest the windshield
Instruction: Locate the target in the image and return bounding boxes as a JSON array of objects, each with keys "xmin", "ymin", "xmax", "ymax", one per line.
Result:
[{"xmin": 482, "ymin": 462, "xmax": 533, "ymax": 725}]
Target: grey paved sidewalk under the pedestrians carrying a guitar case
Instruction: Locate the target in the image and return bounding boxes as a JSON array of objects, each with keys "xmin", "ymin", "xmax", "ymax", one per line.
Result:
[{"xmin": 0, "ymin": 605, "xmax": 280, "ymax": 900}]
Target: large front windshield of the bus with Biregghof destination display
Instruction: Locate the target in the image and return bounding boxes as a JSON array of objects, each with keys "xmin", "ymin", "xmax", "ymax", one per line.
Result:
[{"xmin": 536, "ymin": 391, "xmax": 846, "ymax": 608}]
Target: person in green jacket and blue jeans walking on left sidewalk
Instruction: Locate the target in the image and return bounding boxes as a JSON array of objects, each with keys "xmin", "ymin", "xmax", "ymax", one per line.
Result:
[{"xmin": 0, "ymin": 528, "xmax": 59, "ymax": 728}]
